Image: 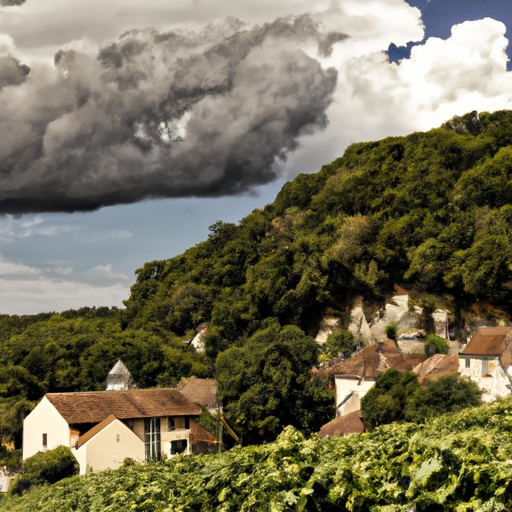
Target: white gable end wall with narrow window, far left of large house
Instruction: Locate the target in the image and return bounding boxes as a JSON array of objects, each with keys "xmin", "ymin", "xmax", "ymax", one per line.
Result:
[{"xmin": 23, "ymin": 397, "xmax": 70, "ymax": 460}]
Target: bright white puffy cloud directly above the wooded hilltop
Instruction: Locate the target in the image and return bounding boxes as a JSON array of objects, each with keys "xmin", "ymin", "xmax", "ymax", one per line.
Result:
[{"xmin": 285, "ymin": 18, "xmax": 512, "ymax": 175}]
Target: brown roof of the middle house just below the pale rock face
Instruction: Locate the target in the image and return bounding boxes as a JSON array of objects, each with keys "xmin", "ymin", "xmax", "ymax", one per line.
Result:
[{"xmin": 317, "ymin": 341, "xmax": 426, "ymax": 379}]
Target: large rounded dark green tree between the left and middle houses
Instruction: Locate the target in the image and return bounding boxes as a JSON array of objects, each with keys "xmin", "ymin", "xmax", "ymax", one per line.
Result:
[{"xmin": 215, "ymin": 321, "xmax": 334, "ymax": 443}]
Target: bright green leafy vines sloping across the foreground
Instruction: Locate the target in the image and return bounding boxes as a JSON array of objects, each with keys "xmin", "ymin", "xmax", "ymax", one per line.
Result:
[{"xmin": 0, "ymin": 400, "xmax": 512, "ymax": 512}]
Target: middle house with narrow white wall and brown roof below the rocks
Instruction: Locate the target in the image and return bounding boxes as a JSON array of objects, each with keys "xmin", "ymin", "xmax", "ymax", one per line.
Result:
[{"xmin": 314, "ymin": 341, "xmax": 426, "ymax": 416}]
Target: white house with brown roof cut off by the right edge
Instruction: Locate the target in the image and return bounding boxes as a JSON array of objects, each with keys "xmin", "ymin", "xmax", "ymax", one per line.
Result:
[{"xmin": 459, "ymin": 327, "xmax": 512, "ymax": 402}]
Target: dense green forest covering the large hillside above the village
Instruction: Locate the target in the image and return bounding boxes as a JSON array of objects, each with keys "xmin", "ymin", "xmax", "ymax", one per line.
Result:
[{"xmin": 124, "ymin": 111, "xmax": 512, "ymax": 352}]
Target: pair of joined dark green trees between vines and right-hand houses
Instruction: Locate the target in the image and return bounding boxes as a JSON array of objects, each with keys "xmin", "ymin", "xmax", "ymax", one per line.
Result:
[{"xmin": 361, "ymin": 369, "xmax": 482, "ymax": 430}]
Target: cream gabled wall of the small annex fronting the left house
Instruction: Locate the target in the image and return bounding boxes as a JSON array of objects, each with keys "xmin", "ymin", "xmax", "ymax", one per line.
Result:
[{"xmin": 73, "ymin": 419, "xmax": 144, "ymax": 475}]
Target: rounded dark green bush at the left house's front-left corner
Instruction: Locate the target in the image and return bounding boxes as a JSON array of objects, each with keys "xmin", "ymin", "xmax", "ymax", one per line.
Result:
[{"xmin": 11, "ymin": 446, "xmax": 80, "ymax": 495}]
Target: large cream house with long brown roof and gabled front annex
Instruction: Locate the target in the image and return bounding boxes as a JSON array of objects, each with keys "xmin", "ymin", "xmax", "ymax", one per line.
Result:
[{"xmin": 23, "ymin": 389, "xmax": 217, "ymax": 474}]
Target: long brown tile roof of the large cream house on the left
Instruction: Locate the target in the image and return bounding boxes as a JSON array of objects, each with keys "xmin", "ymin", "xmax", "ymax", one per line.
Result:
[{"xmin": 46, "ymin": 388, "xmax": 201, "ymax": 425}]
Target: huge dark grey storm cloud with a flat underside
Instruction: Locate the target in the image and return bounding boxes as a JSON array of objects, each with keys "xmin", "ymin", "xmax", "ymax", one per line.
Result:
[{"xmin": 0, "ymin": 15, "xmax": 344, "ymax": 213}]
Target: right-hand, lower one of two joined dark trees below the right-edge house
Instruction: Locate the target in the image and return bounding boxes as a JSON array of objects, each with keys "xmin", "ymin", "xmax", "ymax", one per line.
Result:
[{"xmin": 405, "ymin": 373, "xmax": 482, "ymax": 422}]
